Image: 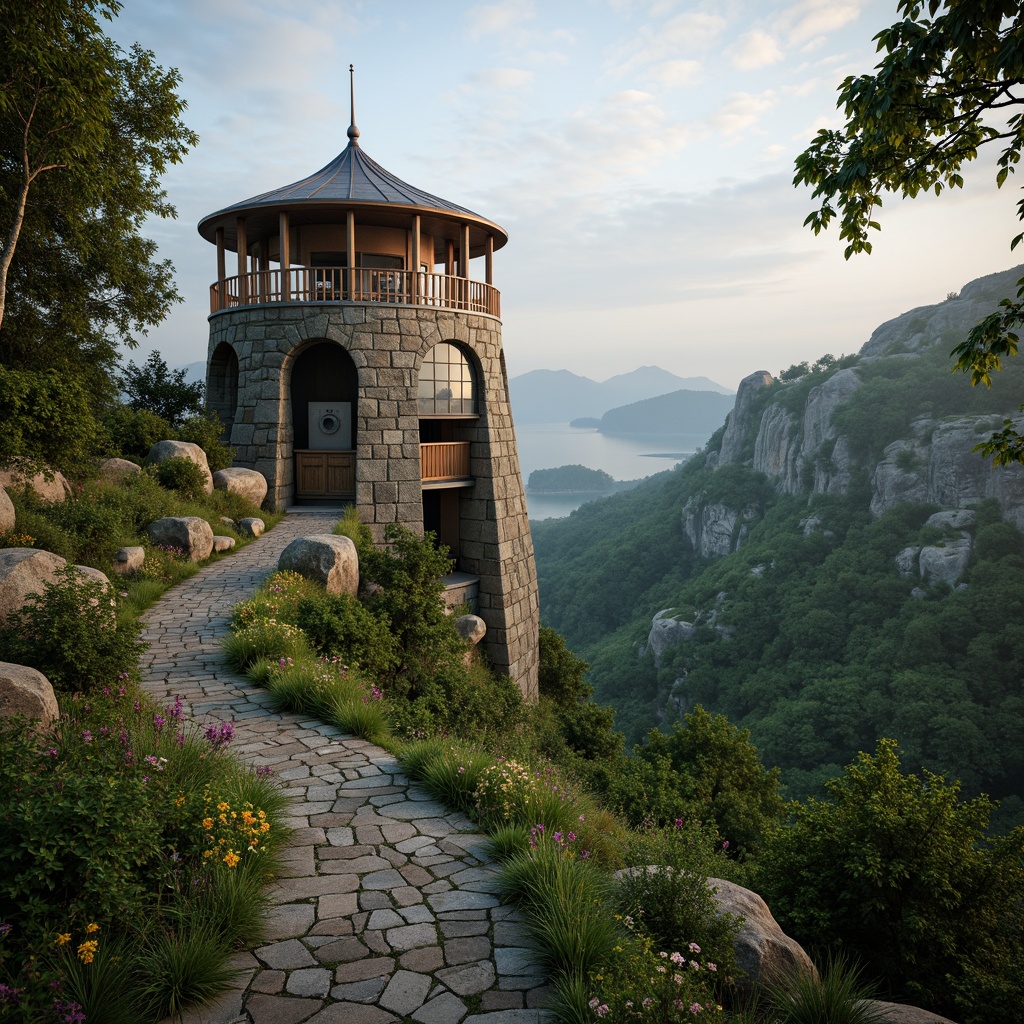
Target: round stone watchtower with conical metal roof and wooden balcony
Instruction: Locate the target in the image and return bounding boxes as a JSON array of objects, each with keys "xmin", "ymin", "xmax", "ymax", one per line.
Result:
[{"xmin": 199, "ymin": 77, "xmax": 539, "ymax": 697}]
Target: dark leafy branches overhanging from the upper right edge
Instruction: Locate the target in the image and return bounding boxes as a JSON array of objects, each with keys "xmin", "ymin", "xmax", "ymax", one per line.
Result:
[{"xmin": 794, "ymin": 0, "xmax": 1024, "ymax": 464}]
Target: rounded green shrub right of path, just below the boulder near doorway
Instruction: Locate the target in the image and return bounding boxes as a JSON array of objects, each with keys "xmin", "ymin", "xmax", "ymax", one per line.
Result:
[{"xmin": 295, "ymin": 590, "xmax": 398, "ymax": 678}]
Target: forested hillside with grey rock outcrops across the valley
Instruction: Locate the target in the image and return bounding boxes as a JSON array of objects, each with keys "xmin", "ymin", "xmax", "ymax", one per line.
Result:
[{"xmin": 534, "ymin": 269, "xmax": 1024, "ymax": 823}]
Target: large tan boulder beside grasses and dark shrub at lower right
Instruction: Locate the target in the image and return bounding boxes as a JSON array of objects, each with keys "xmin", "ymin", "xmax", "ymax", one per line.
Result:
[{"xmin": 708, "ymin": 879, "xmax": 817, "ymax": 988}]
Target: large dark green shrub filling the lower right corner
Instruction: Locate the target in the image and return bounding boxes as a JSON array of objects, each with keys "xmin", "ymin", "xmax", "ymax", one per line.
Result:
[{"xmin": 757, "ymin": 739, "xmax": 1024, "ymax": 1024}]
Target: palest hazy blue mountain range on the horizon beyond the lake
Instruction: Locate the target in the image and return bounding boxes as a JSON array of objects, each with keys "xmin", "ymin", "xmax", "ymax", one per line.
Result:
[{"xmin": 509, "ymin": 367, "xmax": 733, "ymax": 423}]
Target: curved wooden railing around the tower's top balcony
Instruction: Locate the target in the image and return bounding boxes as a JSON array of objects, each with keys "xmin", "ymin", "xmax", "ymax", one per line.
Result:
[{"xmin": 210, "ymin": 266, "xmax": 501, "ymax": 316}]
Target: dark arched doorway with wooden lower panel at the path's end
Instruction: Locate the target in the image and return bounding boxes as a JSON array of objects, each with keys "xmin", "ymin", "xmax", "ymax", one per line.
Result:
[{"xmin": 292, "ymin": 341, "xmax": 358, "ymax": 504}]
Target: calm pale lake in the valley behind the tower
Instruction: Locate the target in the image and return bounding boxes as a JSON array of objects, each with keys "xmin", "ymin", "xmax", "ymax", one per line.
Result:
[{"xmin": 515, "ymin": 423, "xmax": 708, "ymax": 519}]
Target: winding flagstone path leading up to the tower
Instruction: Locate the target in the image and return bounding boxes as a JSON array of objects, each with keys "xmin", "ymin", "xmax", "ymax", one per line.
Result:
[{"xmin": 142, "ymin": 508, "xmax": 551, "ymax": 1024}]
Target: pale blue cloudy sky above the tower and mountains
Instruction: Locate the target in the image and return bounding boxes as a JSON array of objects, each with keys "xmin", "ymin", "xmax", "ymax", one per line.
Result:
[{"xmin": 111, "ymin": 0, "xmax": 1019, "ymax": 388}]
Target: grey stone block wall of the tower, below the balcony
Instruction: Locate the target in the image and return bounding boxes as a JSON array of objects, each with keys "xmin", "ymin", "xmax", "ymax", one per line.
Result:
[{"xmin": 209, "ymin": 303, "xmax": 540, "ymax": 698}]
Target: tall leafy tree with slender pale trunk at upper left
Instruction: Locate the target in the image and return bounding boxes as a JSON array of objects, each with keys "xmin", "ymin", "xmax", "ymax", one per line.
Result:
[{"xmin": 0, "ymin": 0, "xmax": 198, "ymax": 396}]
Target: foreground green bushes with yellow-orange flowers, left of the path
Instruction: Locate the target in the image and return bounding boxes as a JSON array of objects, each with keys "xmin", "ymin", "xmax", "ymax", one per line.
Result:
[{"xmin": 0, "ymin": 682, "xmax": 287, "ymax": 1022}]
